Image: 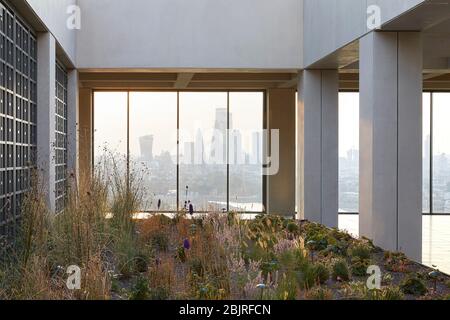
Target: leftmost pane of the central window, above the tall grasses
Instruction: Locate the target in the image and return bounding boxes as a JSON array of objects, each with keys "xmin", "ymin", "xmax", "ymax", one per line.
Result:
[{"xmin": 94, "ymin": 92, "xmax": 128, "ymax": 175}]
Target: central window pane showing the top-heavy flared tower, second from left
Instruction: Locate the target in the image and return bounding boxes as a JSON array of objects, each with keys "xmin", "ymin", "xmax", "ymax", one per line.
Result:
[{"xmin": 130, "ymin": 92, "xmax": 177, "ymax": 211}]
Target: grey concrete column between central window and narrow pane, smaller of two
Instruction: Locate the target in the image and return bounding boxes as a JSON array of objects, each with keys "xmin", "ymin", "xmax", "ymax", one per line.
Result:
[{"xmin": 297, "ymin": 70, "xmax": 339, "ymax": 227}]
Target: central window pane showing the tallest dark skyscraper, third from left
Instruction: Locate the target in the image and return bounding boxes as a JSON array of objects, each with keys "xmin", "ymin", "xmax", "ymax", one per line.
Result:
[{"xmin": 179, "ymin": 92, "xmax": 228, "ymax": 211}]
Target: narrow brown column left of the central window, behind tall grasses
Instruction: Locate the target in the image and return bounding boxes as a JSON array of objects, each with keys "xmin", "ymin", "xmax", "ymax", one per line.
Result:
[{"xmin": 78, "ymin": 88, "xmax": 94, "ymax": 180}]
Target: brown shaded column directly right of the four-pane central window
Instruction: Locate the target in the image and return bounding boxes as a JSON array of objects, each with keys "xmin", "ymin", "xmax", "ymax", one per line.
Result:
[{"xmin": 266, "ymin": 89, "xmax": 295, "ymax": 217}]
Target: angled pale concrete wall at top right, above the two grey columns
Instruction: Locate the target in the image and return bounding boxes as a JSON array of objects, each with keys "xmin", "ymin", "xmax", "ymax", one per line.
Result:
[{"xmin": 304, "ymin": 0, "xmax": 425, "ymax": 67}]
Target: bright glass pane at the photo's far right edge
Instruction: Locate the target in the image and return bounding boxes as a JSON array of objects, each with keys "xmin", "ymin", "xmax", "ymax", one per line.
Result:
[{"xmin": 433, "ymin": 93, "xmax": 450, "ymax": 213}]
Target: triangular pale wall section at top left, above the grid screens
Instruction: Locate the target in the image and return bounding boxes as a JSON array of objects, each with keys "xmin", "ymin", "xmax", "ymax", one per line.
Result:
[{"xmin": 26, "ymin": 0, "xmax": 77, "ymax": 64}]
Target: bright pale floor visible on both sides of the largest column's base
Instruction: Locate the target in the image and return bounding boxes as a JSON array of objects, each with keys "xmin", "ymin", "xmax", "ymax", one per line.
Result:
[{"xmin": 339, "ymin": 214, "xmax": 450, "ymax": 274}]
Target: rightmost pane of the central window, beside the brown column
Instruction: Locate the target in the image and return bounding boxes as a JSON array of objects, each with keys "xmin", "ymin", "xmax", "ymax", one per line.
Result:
[{"xmin": 229, "ymin": 92, "xmax": 264, "ymax": 212}]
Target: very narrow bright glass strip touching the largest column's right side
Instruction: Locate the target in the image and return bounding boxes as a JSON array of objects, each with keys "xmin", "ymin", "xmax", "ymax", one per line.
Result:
[{"xmin": 422, "ymin": 92, "xmax": 431, "ymax": 213}]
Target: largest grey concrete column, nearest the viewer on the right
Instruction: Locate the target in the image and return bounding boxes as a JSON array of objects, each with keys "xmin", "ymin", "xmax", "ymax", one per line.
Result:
[{"xmin": 359, "ymin": 32, "xmax": 422, "ymax": 261}]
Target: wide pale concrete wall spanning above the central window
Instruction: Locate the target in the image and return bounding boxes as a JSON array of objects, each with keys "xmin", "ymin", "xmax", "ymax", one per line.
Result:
[{"xmin": 76, "ymin": 0, "xmax": 302, "ymax": 69}]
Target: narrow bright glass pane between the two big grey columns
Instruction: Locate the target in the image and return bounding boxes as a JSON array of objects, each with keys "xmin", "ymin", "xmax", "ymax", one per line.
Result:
[{"xmin": 339, "ymin": 92, "xmax": 359, "ymax": 212}]
